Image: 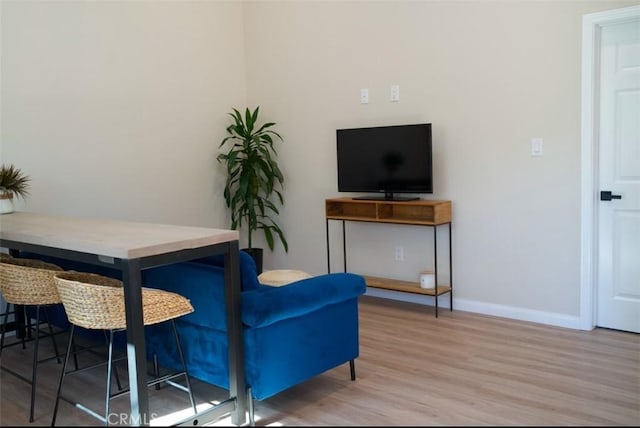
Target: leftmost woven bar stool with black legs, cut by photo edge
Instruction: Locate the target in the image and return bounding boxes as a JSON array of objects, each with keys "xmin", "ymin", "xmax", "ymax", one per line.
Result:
[{"xmin": 0, "ymin": 255, "xmax": 63, "ymax": 422}]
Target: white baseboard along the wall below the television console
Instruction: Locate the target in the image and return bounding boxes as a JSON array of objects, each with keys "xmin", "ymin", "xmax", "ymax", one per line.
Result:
[{"xmin": 366, "ymin": 287, "xmax": 582, "ymax": 330}]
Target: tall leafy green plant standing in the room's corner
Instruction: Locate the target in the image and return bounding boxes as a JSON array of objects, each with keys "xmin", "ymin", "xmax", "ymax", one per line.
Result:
[{"xmin": 217, "ymin": 106, "xmax": 289, "ymax": 274}]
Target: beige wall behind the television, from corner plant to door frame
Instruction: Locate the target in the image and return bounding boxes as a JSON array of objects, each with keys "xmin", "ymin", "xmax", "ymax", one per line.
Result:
[{"xmin": 245, "ymin": 1, "xmax": 632, "ymax": 317}]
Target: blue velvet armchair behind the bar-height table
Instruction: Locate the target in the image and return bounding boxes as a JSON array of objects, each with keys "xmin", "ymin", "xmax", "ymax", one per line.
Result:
[{"xmin": 143, "ymin": 252, "xmax": 366, "ymax": 419}]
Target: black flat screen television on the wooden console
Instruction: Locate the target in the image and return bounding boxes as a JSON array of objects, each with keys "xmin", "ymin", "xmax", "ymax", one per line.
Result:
[{"xmin": 336, "ymin": 123, "xmax": 433, "ymax": 200}]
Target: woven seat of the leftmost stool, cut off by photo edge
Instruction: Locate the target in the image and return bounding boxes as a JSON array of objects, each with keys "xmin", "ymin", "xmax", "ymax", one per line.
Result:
[{"xmin": 0, "ymin": 257, "xmax": 63, "ymax": 305}]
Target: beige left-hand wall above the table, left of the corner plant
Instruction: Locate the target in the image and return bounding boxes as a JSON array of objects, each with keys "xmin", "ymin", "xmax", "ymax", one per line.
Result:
[{"xmin": 1, "ymin": 1, "xmax": 246, "ymax": 227}]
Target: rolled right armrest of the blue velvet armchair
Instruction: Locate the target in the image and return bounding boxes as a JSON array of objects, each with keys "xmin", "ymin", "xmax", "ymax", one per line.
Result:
[{"xmin": 242, "ymin": 273, "xmax": 366, "ymax": 327}]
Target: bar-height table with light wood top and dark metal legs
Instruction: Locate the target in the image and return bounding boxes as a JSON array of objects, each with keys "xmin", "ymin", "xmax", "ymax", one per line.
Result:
[{"xmin": 0, "ymin": 212, "xmax": 247, "ymax": 426}]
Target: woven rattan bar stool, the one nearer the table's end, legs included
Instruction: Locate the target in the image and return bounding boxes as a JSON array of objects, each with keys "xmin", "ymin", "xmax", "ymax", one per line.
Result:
[{"xmin": 51, "ymin": 271, "xmax": 197, "ymax": 426}]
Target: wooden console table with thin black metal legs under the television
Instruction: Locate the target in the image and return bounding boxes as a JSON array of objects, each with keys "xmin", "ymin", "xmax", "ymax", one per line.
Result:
[{"xmin": 325, "ymin": 198, "xmax": 453, "ymax": 318}]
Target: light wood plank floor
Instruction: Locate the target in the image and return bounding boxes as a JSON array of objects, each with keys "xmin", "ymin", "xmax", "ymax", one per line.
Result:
[{"xmin": 0, "ymin": 296, "xmax": 640, "ymax": 426}]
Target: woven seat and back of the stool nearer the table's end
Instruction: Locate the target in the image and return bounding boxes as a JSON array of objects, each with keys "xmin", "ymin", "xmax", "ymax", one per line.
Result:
[{"xmin": 55, "ymin": 271, "xmax": 193, "ymax": 330}]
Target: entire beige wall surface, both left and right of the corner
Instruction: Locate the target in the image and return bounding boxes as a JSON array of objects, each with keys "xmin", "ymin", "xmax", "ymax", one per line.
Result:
[{"xmin": 0, "ymin": 1, "xmax": 637, "ymax": 326}]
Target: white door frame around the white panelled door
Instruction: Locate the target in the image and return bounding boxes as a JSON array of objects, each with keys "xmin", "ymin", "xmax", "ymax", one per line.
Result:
[{"xmin": 579, "ymin": 6, "xmax": 640, "ymax": 330}]
